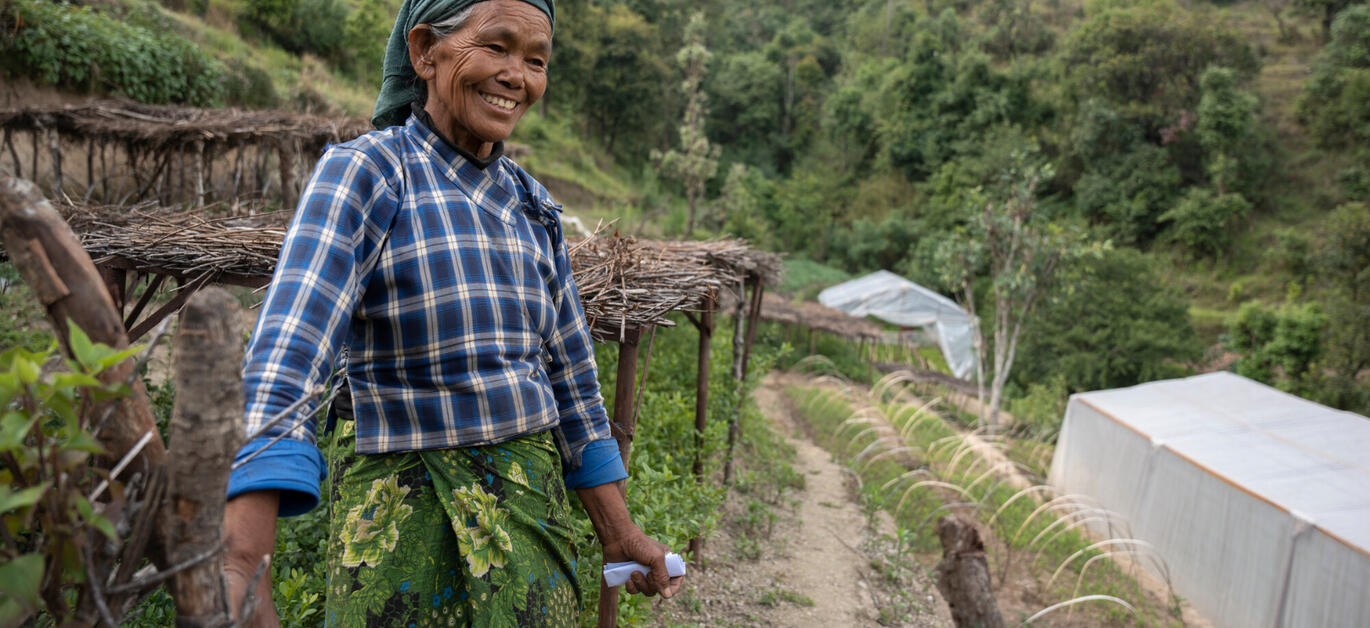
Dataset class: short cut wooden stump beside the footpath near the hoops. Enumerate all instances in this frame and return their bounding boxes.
[937,516,1004,628]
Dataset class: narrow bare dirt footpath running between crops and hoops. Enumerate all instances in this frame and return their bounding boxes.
[662,376,951,628]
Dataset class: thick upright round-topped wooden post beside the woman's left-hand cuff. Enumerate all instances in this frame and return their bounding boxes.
[160,288,242,628]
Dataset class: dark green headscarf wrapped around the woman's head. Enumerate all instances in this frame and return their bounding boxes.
[371,0,556,129]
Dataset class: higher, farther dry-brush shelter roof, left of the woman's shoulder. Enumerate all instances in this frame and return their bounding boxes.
[0,100,371,152]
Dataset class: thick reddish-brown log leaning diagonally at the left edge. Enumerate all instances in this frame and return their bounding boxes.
[0,178,166,496]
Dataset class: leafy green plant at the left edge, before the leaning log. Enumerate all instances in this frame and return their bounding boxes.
[0,320,140,625]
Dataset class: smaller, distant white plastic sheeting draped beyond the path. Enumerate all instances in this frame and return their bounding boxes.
[818,270,975,380]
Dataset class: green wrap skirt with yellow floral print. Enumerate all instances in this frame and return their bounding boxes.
[325,421,581,628]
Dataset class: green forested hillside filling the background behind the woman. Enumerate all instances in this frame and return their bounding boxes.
[0,0,1370,421]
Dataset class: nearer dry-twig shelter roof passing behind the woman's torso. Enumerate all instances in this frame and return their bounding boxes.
[18,206,780,340]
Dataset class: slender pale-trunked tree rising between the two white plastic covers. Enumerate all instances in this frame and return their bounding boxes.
[938,152,1107,429]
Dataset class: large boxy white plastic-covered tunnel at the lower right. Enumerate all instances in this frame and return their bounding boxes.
[1049,373,1370,628]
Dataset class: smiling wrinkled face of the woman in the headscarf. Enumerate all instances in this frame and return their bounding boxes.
[410,0,552,156]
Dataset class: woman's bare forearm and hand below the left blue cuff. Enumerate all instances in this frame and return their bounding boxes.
[223,491,281,628]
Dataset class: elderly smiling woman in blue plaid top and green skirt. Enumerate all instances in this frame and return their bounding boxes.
[225,0,681,627]
